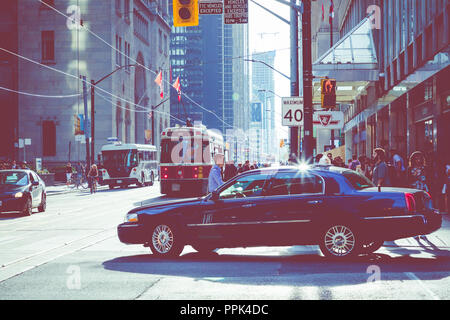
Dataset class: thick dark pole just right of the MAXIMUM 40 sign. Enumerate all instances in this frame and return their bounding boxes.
[302,0,314,162]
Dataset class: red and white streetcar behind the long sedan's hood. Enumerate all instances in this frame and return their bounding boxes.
[160,126,224,196]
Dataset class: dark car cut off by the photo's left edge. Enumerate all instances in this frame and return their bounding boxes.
[0,169,47,215]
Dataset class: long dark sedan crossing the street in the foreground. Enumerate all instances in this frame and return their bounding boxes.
[118,166,442,257]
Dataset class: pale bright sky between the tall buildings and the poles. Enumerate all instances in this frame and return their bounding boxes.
[248,0,290,138]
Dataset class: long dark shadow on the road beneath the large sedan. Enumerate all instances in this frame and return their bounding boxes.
[103,247,450,286]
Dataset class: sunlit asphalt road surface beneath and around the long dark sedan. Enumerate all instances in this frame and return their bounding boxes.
[0,184,450,300]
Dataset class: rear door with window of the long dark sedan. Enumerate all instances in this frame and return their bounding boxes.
[265,171,325,245]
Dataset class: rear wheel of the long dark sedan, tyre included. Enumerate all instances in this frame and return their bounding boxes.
[320,224,359,259]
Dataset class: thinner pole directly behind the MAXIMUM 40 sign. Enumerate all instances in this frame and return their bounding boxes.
[289,0,300,157]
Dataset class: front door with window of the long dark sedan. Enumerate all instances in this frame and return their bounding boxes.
[192,172,270,245]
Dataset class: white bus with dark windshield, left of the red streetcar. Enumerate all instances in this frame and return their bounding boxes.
[100,143,158,189]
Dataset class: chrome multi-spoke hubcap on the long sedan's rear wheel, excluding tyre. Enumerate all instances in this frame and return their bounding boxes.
[325,226,355,256]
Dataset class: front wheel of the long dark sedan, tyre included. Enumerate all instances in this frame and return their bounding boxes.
[150,224,184,258]
